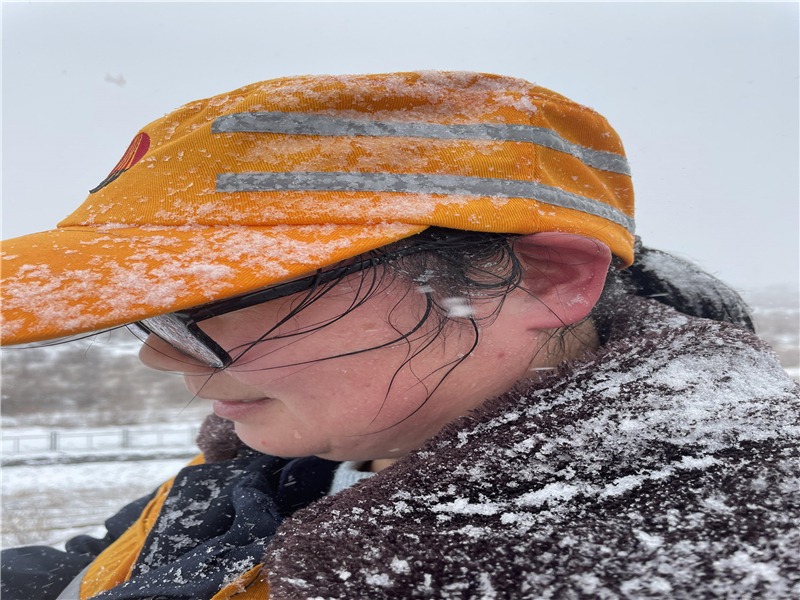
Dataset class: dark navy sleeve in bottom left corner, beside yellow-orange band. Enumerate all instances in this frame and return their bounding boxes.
[0,491,156,600]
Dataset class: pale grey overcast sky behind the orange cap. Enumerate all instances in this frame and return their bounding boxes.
[2,2,800,292]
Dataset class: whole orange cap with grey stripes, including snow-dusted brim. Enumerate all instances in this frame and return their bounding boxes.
[0,72,633,344]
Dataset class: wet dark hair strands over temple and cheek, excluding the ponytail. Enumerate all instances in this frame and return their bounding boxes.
[184,227,523,433]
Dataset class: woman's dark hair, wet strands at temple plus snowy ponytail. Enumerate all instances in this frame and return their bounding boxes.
[192,227,754,424]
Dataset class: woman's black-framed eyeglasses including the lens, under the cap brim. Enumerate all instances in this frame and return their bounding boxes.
[133,245,428,369]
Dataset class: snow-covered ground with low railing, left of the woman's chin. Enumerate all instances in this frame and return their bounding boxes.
[1,419,206,548]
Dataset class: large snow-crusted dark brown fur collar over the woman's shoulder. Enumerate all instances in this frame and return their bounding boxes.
[264,298,800,600]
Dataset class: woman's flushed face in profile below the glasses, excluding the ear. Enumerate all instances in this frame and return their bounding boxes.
[140,275,552,460]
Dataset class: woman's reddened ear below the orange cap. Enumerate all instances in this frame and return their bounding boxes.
[514,232,611,329]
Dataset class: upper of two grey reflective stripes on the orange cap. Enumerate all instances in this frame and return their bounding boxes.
[211,112,631,175]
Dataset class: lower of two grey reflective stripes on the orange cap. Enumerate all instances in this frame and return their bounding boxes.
[216,171,635,233]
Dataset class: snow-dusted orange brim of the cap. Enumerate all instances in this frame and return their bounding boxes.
[0,223,427,345]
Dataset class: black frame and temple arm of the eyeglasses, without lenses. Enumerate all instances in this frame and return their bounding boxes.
[132,244,430,369]
